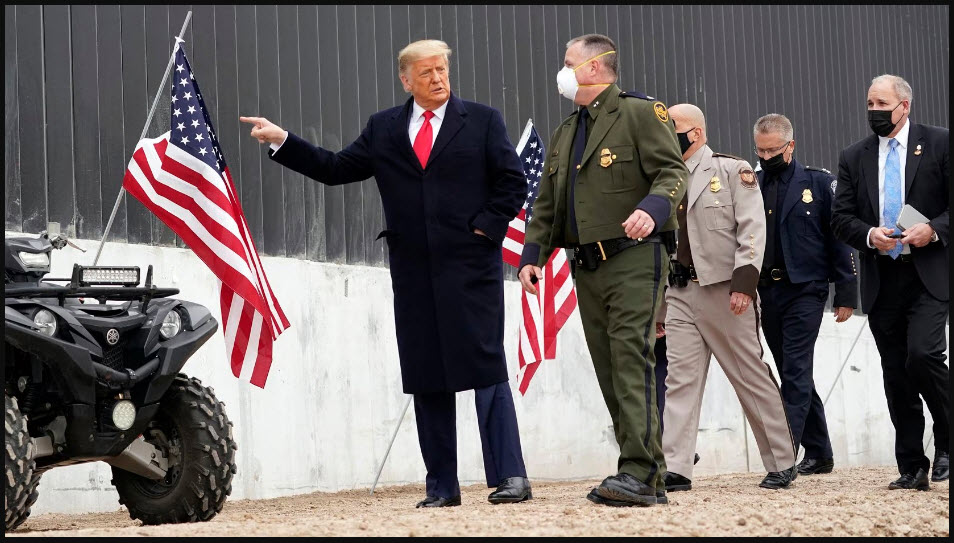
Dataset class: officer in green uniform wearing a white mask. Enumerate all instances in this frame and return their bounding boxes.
[520,34,688,506]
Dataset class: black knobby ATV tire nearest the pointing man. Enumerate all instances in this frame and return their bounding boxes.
[112,374,237,524]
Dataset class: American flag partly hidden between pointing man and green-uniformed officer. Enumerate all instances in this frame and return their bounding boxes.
[503,120,576,394]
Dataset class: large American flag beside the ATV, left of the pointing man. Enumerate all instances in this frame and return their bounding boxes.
[123,43,289,388]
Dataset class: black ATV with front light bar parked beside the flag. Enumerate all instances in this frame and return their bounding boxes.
[3,233,236,530]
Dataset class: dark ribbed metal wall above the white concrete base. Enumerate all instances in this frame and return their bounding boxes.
[4,5,950,265]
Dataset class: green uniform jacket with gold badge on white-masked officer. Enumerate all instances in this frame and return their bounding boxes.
[520,84,689,267]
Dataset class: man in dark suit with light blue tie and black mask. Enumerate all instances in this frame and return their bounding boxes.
[831,75,951,490]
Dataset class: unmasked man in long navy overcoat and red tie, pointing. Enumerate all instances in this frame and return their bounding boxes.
[242,40,531,507]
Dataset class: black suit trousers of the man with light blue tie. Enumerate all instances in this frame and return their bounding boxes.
[868,256,951,474]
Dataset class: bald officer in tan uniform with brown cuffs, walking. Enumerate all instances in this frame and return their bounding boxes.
[662,104,797,491]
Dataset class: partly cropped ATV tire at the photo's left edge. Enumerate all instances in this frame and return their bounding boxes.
[3,394,40,531]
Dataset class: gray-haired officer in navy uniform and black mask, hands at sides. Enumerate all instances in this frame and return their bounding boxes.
[753,113,858,475]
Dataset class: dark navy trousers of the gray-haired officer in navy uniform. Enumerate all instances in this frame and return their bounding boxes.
[759,279,834,458]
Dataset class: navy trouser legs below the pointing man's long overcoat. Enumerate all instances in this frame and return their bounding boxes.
[414,381,527,498]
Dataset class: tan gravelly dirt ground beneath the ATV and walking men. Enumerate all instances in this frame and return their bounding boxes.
[7,467,950,537]
